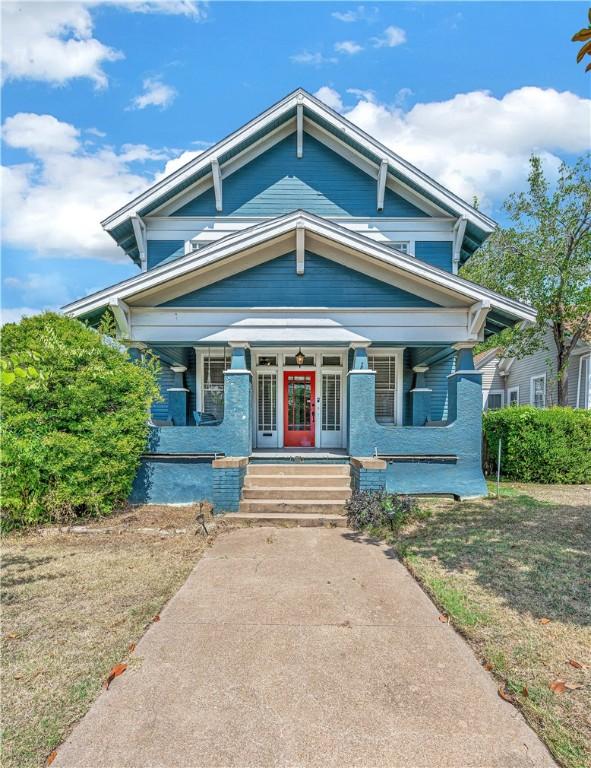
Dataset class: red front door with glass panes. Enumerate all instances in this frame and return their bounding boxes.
[283,371,316,448]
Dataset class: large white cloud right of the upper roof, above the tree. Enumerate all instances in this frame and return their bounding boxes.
[316,86,591,210]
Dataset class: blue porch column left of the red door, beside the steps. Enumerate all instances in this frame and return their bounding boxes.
[223,342,252,456]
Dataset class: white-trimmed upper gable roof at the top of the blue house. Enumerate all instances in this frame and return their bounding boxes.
[101,88,496,262]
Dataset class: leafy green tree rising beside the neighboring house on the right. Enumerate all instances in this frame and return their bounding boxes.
[461,154,591,405]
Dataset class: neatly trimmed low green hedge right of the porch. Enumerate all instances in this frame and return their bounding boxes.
[483,406,591,483]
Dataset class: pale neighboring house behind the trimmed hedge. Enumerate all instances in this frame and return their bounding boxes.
[474,329,591,410]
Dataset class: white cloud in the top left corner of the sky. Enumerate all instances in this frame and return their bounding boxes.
[2,2,123,88]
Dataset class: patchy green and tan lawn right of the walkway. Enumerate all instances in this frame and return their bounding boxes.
[395,484,591,768]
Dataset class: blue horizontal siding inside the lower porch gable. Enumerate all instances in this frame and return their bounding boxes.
[161,252,437,307]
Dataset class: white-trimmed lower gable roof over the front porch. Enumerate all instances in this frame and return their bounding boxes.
[63,211,536,330]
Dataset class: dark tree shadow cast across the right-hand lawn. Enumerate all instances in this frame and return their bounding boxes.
[344,493,591,626]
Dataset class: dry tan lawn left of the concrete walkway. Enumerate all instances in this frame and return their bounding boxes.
[1,507,215,768]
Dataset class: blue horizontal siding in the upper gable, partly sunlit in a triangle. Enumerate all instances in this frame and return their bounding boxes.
[172,133,427,217]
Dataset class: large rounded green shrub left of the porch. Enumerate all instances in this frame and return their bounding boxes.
[1,313,158,530]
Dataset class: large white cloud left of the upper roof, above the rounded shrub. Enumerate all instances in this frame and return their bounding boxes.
[2,113,185,262]
